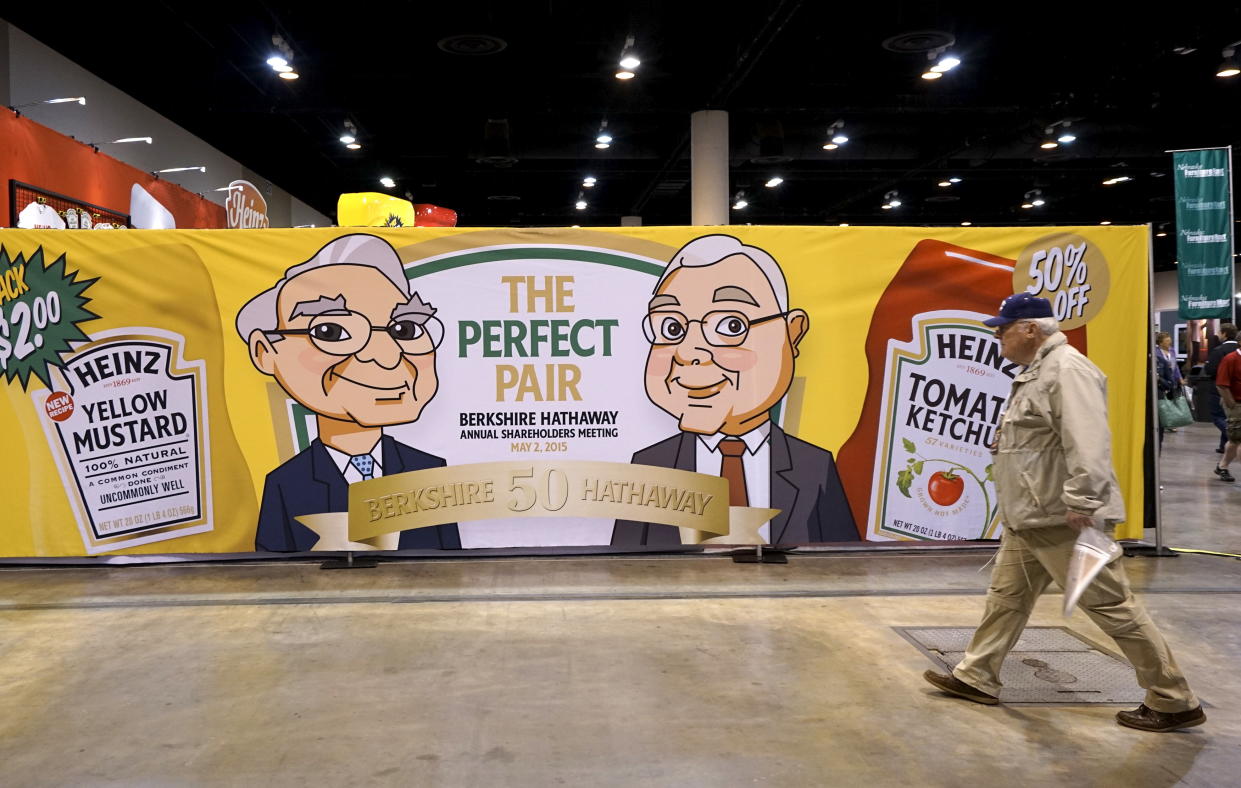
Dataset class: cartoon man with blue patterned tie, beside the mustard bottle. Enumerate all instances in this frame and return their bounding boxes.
[237,233,460,551]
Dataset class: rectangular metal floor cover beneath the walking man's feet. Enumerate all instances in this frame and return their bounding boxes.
[896,627,1145,704]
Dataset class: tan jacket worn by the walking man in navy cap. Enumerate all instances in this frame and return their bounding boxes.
[993,331,1124,530]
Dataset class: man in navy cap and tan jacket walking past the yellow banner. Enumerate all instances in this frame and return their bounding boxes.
[925,293,1201,731]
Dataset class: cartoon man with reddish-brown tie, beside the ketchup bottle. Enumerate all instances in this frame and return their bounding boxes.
[612,235,858,546]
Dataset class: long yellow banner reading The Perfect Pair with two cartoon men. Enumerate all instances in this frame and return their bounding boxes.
[0,227,1148,556]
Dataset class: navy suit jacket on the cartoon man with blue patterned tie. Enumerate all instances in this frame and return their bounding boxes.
[254,436,462,552]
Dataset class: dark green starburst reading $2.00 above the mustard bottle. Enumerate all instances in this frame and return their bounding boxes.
[0,247,99,390]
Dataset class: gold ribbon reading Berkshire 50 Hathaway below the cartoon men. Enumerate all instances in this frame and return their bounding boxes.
[298,460,779,550]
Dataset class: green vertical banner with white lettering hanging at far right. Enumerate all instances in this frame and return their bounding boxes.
[1173,148,1234,320]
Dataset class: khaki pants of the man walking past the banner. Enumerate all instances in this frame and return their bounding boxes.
[952,525,1198,714]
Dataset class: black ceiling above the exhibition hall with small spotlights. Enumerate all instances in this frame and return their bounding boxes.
[4,0,1241,267]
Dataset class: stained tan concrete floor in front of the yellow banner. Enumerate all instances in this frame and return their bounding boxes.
[0,426,1241,787]
